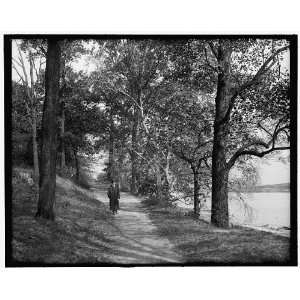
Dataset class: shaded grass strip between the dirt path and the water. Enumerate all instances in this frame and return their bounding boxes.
[145,203,290,265]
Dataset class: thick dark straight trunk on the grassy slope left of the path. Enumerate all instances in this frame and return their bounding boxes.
[36,39,61,220]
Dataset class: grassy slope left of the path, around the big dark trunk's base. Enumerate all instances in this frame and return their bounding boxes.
[12,168,120,263]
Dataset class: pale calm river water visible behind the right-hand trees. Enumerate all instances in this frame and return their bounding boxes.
[178,192,290,236]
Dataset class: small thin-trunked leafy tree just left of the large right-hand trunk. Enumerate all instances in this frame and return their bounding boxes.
[170,93,214,216]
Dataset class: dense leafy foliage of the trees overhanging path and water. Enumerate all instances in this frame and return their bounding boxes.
[12,38,291,221]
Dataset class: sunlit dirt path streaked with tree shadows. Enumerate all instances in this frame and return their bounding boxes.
[90,188,181,264]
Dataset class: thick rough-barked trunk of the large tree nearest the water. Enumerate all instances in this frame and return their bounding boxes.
[211,46,232,228]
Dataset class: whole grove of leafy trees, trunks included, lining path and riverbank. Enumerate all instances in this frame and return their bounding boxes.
[12,36,290,228]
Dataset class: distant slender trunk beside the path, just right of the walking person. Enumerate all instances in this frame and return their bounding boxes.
[130,111,140,194]
